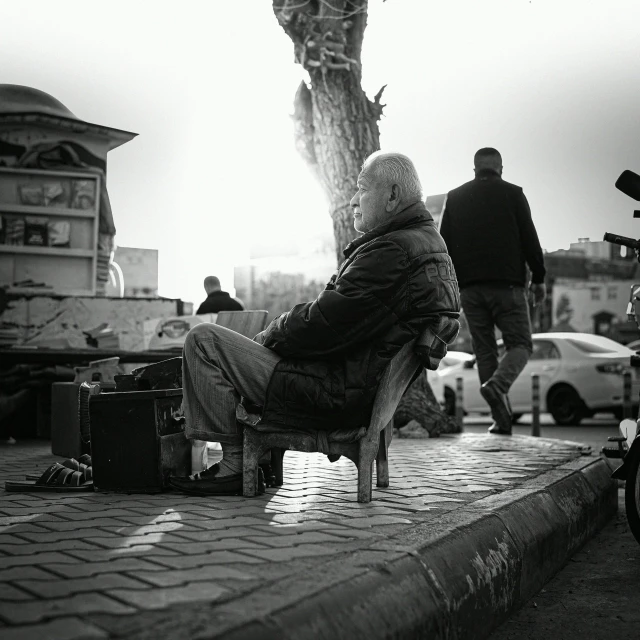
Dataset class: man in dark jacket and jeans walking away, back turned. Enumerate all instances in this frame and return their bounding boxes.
[440,148,546,435]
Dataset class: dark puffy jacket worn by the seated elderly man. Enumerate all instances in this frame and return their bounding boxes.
[255,202,460,430]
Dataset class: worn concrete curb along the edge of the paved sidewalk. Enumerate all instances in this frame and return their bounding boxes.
[198,458,618,640]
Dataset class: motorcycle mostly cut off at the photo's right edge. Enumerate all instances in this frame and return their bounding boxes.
[602,170,640,543]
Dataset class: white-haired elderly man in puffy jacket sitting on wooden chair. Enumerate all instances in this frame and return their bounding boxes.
[171,152,460,495]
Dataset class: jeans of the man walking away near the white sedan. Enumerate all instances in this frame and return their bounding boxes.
[460,285,533,393]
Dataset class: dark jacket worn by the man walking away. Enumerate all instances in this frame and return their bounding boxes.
[440,172,545,289]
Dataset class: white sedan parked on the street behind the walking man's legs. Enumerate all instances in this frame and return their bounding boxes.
[438,333,640,425]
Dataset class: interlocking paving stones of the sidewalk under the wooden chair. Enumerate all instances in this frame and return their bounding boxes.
[0,434,580,640]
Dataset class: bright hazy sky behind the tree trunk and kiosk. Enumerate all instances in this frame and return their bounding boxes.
[0,0,640,301]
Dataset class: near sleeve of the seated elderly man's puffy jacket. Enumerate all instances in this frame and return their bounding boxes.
[256,240,409,359]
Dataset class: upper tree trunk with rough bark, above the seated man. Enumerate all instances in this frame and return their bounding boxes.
[273,0,384,264]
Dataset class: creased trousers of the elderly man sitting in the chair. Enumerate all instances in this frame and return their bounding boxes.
[182,323,281,448]
